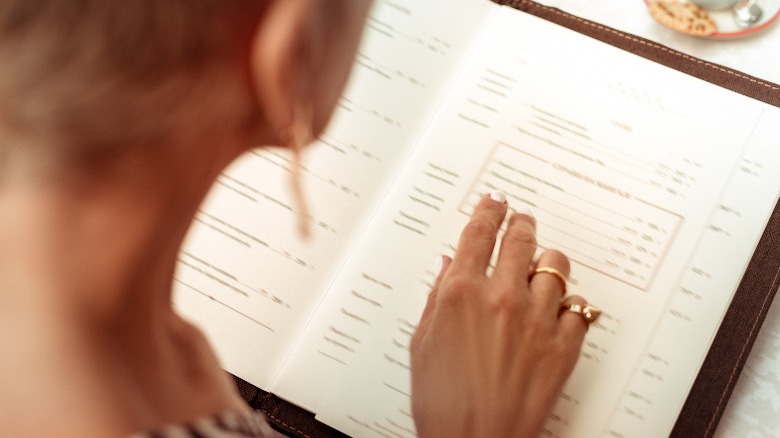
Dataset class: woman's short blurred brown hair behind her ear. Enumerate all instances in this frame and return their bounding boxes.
[0,0,266,167]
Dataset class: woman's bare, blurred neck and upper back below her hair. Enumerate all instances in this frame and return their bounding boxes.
[0,146,247,436]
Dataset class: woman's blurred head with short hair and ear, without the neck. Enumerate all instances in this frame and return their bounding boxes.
[0,0,369,176]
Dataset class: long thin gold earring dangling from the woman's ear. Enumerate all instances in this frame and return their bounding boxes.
[285,102,314,238]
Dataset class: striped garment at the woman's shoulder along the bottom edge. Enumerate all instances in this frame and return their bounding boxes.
[128,411,284,438]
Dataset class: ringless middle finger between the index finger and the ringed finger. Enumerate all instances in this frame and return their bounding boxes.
[493,212,536,284]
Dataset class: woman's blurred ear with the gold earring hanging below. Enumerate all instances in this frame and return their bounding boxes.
[249,0,316,144]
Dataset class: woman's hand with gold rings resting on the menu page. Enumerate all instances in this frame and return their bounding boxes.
[411,194,587,438]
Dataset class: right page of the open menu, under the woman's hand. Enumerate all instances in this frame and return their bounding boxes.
[300,9,780,436]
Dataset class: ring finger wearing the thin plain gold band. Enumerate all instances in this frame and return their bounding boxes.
[529,249,571,314]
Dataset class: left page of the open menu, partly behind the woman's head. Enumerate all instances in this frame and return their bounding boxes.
[175,0,496,388]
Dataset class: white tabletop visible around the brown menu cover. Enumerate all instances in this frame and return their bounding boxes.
[536,0,780,438]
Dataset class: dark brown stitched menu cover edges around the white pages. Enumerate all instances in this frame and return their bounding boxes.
[236,0,780,437]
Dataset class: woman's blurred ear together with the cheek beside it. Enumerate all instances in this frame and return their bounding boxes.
[250,0,371,144]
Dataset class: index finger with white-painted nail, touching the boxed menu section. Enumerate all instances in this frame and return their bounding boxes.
[452,192,507,275]
